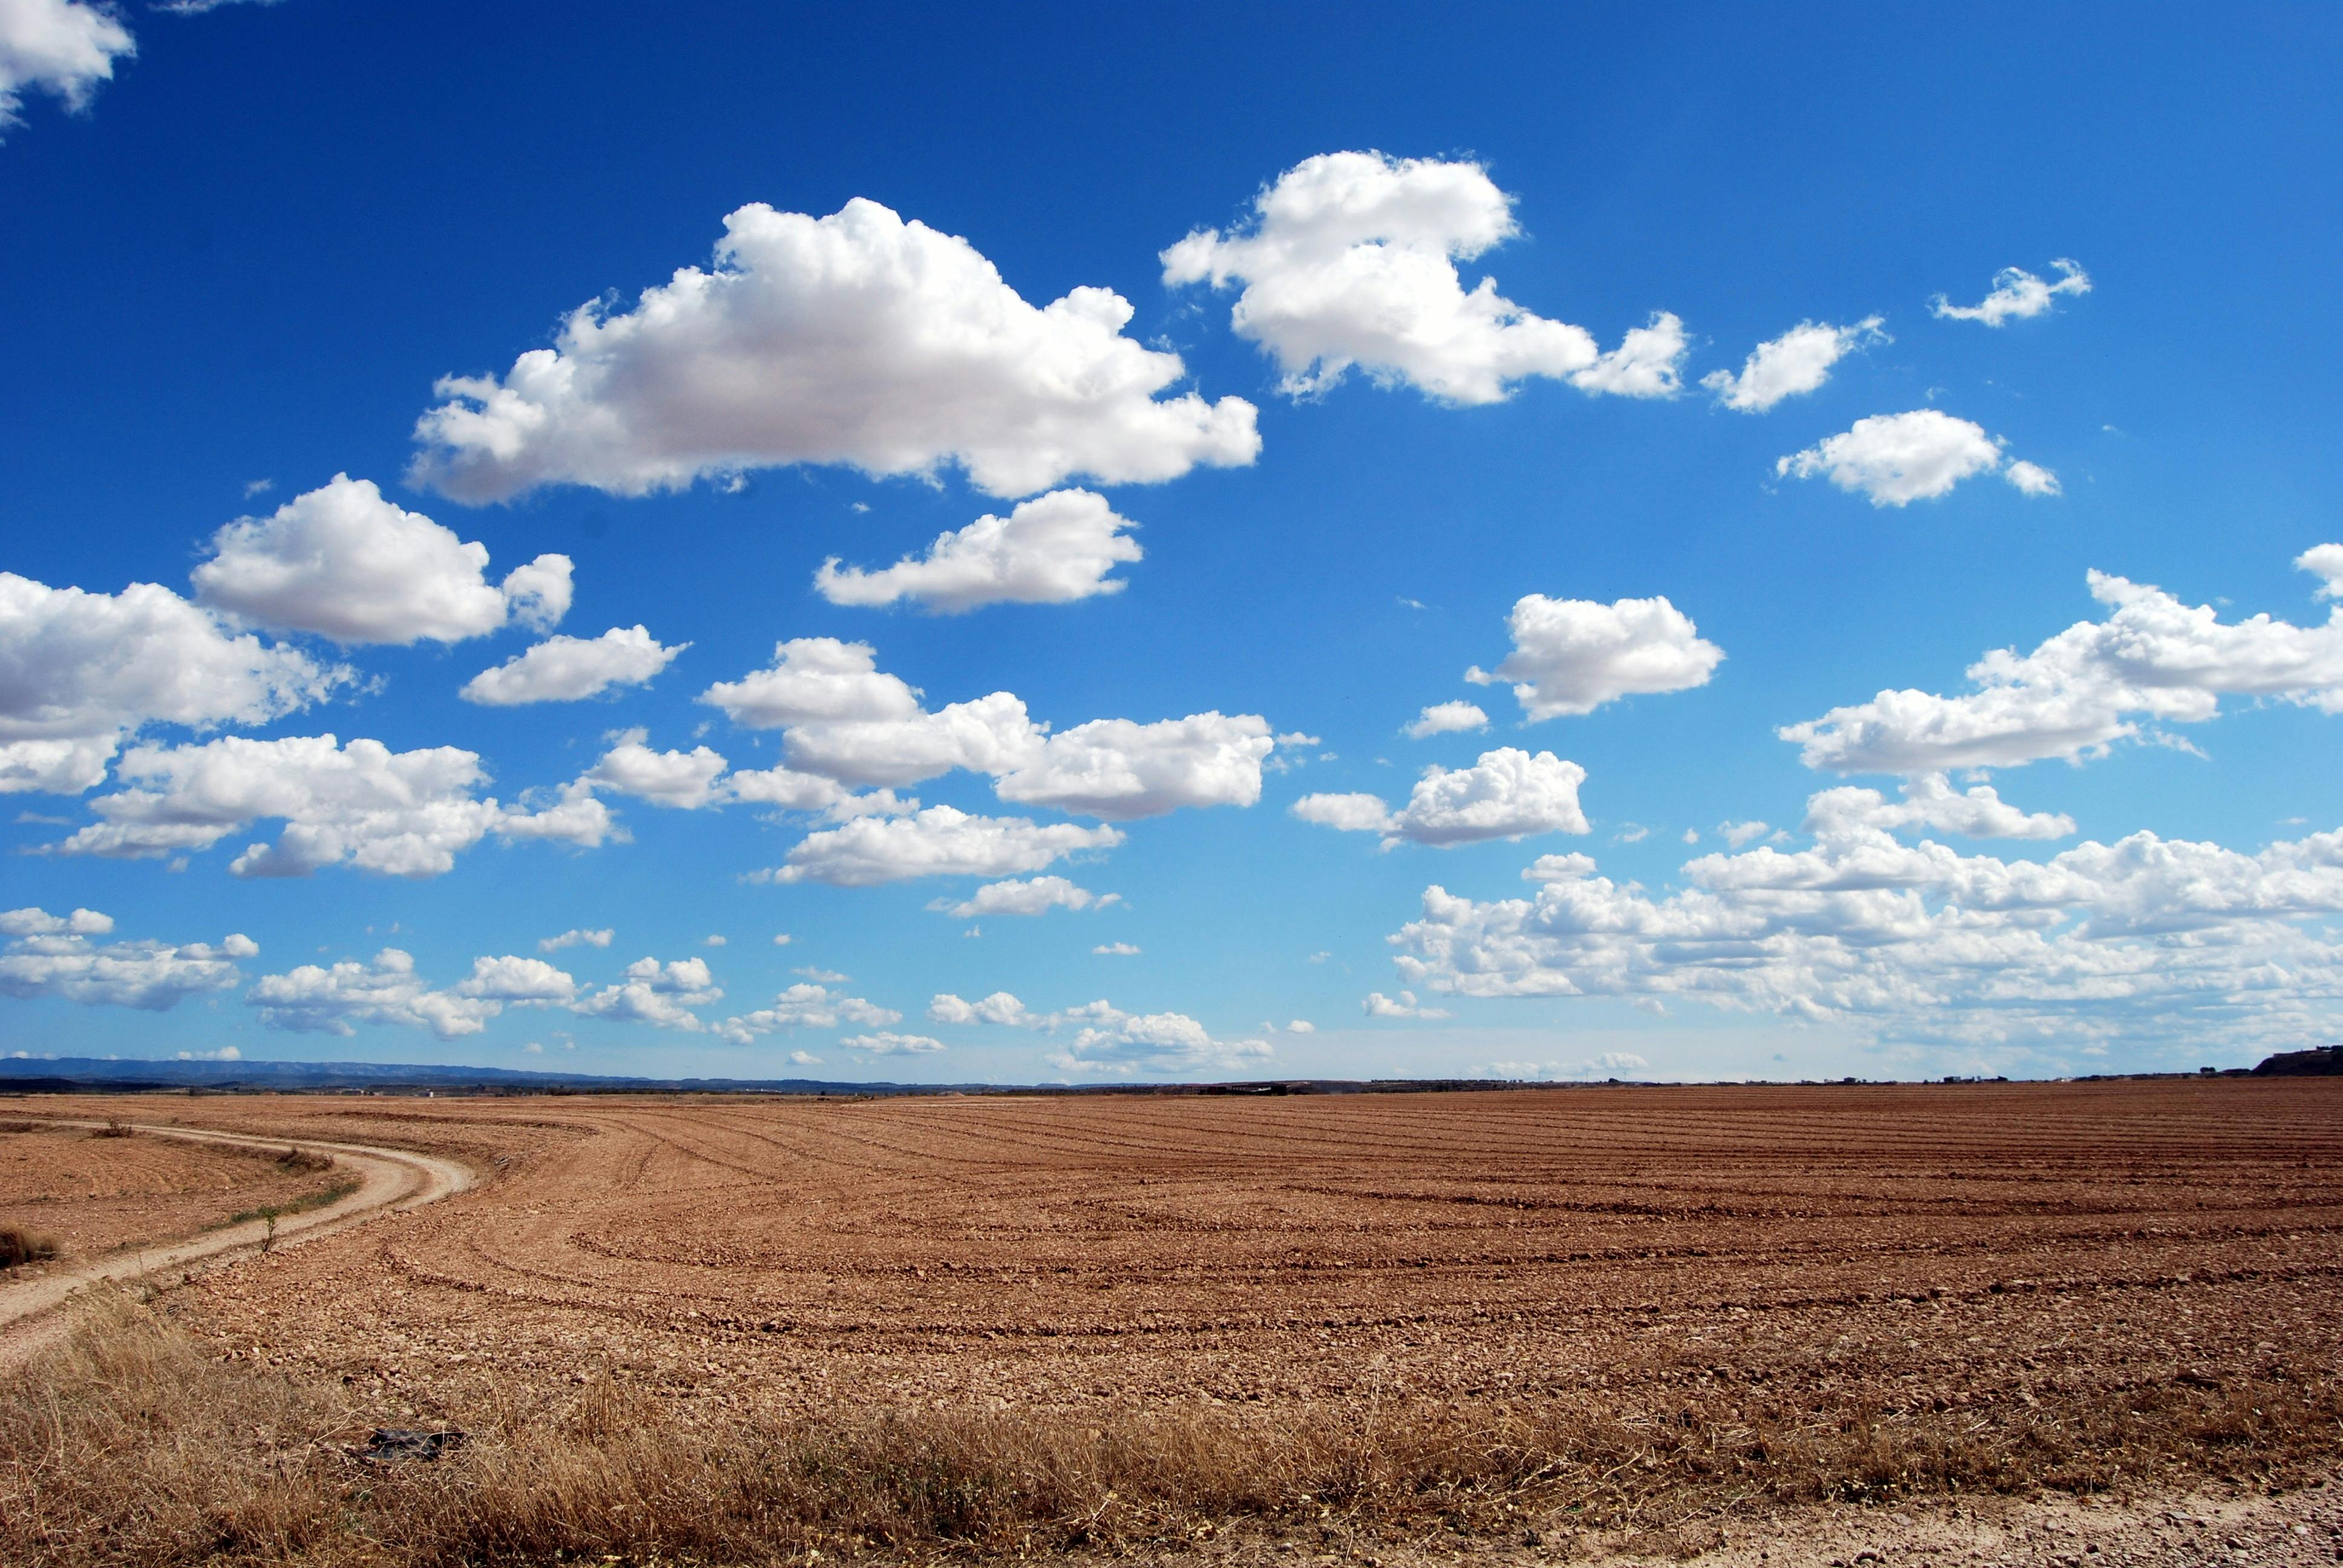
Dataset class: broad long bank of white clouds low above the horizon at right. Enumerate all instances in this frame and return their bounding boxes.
[1392,783,2343,1050]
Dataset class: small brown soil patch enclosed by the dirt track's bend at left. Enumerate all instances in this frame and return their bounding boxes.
[0,1116,351,1261]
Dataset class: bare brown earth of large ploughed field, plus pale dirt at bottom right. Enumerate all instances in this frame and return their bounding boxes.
[0,1080,2343,1568]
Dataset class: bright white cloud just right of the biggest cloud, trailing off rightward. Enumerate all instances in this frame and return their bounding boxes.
[1162,152,1685,403]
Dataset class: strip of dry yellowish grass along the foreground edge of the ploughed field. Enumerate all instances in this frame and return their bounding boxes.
[0,1296,2343,1568]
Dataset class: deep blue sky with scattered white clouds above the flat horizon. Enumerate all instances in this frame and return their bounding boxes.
[0,0,2343,1080]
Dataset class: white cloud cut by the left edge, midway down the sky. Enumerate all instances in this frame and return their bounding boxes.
[0,572,352,794]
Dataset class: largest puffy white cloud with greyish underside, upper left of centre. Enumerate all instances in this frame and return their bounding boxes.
[415,199,1260,501]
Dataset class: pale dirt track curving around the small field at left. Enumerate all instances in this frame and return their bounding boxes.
[0,1118,473,1367]
